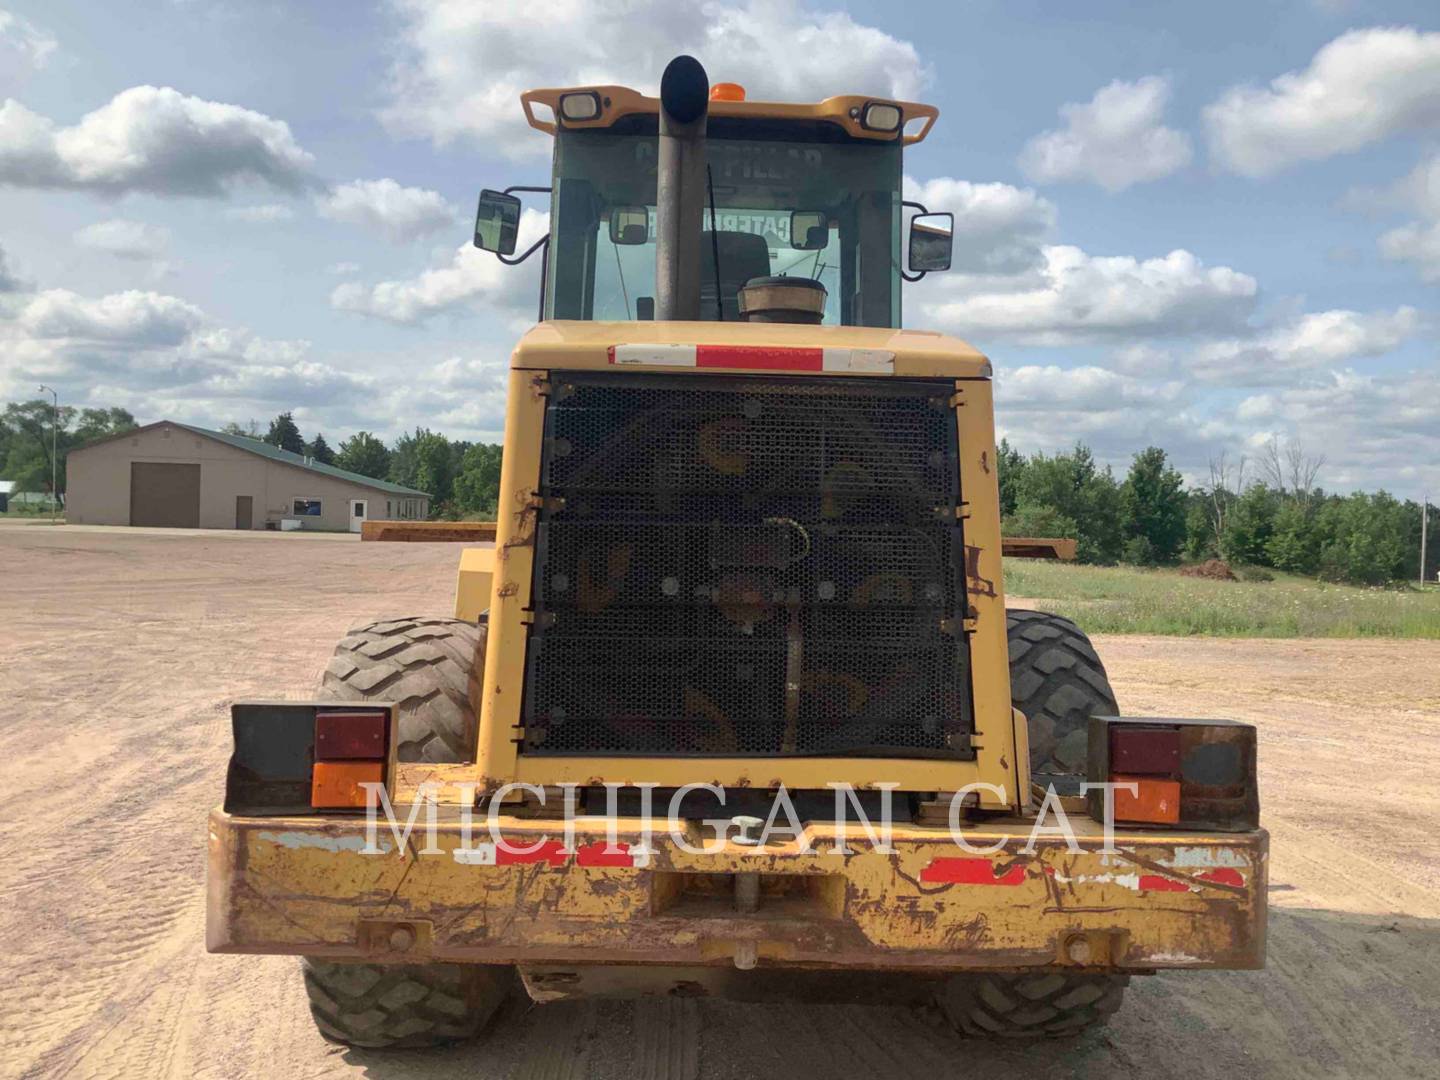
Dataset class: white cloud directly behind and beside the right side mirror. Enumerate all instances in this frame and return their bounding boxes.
[904,176,1056,274]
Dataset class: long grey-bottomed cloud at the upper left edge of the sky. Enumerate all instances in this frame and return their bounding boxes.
[0,86,312,196]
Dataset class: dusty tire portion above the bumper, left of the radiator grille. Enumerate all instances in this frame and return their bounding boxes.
[320,618,485,763]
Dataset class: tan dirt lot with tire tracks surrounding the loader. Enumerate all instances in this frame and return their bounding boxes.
[0,524,1440,1080]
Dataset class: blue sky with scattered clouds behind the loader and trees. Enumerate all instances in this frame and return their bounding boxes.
[0,0,1440,497]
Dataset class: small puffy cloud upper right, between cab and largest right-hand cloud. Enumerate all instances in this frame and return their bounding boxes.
[1020,75,1192,192]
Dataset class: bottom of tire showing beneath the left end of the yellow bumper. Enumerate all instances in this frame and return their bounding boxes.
[301,958,516,1048]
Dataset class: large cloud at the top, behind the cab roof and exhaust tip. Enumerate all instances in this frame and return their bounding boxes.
[380,0,929,157]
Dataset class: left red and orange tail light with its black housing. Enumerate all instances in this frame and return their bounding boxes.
[225,701,393,816]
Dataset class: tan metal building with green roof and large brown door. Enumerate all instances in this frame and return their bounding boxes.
[65,420,431,533]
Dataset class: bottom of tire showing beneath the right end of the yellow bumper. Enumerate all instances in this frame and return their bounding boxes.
[936,971,1130,1038]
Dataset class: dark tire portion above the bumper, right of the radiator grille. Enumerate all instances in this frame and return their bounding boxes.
[1005,611,1119,788]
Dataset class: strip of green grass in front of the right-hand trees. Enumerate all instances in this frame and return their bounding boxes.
[1005,559,1440,638]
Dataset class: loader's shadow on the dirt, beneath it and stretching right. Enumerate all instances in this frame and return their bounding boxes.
[334,907,1440,1080]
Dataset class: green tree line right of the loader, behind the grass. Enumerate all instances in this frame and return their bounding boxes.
[996,441,1440,585]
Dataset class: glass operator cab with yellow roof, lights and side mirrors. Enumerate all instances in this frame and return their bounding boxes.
[475,84,953,327]
